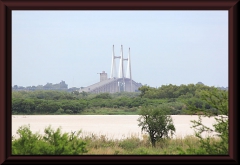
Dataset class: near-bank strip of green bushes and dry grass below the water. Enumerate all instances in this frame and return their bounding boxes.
[12,126,224,155]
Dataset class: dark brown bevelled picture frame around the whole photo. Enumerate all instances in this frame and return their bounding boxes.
[0,0,239,164]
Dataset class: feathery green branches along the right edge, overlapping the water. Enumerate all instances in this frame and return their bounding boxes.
[181,89,229,154]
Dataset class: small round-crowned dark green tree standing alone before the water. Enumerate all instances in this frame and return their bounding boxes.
[137,106,176,147]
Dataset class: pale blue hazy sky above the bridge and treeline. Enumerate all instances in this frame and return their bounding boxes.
[12,10,228,88]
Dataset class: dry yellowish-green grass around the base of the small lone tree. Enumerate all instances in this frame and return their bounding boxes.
[79,135,217,155]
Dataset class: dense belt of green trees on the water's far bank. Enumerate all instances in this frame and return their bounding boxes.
[12,83,227,115]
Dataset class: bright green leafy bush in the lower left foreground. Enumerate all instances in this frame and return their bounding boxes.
[12,125,87,155]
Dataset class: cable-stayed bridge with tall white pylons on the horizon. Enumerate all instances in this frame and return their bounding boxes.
[79,46,142,93]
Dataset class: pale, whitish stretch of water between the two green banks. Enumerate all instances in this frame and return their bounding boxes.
[12,115,219,139]
